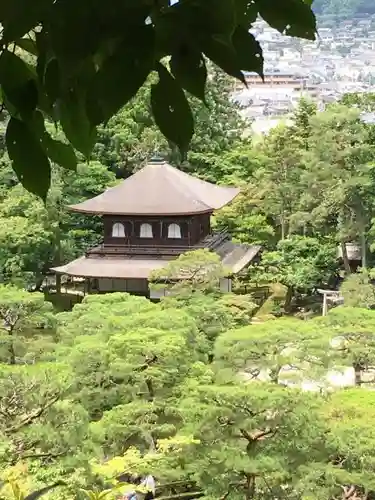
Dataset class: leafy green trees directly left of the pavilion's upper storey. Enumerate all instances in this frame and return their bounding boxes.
[0,162,115,289]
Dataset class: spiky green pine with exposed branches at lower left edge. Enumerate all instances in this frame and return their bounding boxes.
[0,363,90,470]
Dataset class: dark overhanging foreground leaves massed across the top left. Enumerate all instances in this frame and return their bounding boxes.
[0,0,316,199]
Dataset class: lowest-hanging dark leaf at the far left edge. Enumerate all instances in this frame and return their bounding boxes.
[5,118,51,201]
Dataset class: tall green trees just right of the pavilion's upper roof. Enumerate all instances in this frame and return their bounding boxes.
[215,99,316,248]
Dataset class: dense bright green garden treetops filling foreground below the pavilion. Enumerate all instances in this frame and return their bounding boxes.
[0,278,375,500]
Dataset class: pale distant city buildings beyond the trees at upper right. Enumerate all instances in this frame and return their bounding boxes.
[233,16,375,133]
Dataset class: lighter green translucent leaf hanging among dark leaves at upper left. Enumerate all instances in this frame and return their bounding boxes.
[57,90,96,158]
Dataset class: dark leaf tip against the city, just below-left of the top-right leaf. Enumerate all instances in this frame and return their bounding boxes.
[232,26,264,76]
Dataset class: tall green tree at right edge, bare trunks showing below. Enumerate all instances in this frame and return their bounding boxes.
[301,105,374,269]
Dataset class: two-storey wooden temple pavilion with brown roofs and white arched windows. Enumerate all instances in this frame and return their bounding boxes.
[52,158,260,298]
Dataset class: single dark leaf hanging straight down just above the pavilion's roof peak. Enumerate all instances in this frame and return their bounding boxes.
[151,64,194,152]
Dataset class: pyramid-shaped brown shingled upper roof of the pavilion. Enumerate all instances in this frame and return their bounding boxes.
[69,160,240,215]
